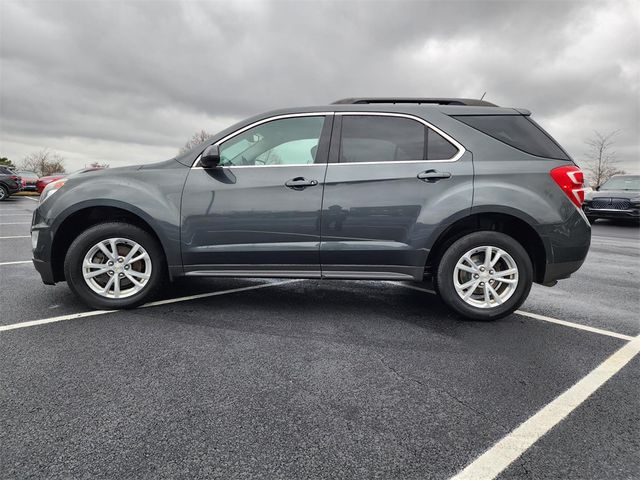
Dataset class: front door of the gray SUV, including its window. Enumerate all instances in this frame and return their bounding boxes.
[181,114,333,278]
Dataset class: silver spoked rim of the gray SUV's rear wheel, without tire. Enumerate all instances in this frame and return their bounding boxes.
[453,245,518,308]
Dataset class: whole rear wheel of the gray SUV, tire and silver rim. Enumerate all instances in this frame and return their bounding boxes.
[436,231,533,320]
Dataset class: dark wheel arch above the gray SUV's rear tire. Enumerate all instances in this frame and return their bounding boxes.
[425,207,549,283]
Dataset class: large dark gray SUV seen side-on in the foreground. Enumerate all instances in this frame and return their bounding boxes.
[32,98,591,320]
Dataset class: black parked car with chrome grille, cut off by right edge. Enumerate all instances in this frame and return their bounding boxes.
[582,175,640,223]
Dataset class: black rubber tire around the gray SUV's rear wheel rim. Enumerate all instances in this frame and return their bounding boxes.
[435,231,533,321]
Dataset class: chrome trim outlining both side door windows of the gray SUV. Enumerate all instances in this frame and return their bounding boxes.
[191,111,467,170]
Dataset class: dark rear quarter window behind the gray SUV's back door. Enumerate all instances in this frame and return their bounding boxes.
[454,115,569,160]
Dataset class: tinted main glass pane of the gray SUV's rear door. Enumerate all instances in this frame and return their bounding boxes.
[340,115,426,163]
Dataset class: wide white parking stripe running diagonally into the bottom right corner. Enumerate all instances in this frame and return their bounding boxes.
[451,336,640,480]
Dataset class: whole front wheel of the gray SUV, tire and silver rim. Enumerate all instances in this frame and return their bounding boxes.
[64,222,166,309]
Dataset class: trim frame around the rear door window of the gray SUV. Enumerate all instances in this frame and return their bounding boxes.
[329,111,467,165]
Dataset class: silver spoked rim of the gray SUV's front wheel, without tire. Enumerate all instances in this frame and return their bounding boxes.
[82,238,151,299]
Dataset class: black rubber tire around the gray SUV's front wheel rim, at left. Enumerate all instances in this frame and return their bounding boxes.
[64,222,167,310]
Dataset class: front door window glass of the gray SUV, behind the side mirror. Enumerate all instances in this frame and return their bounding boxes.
[220,116,325,166]
